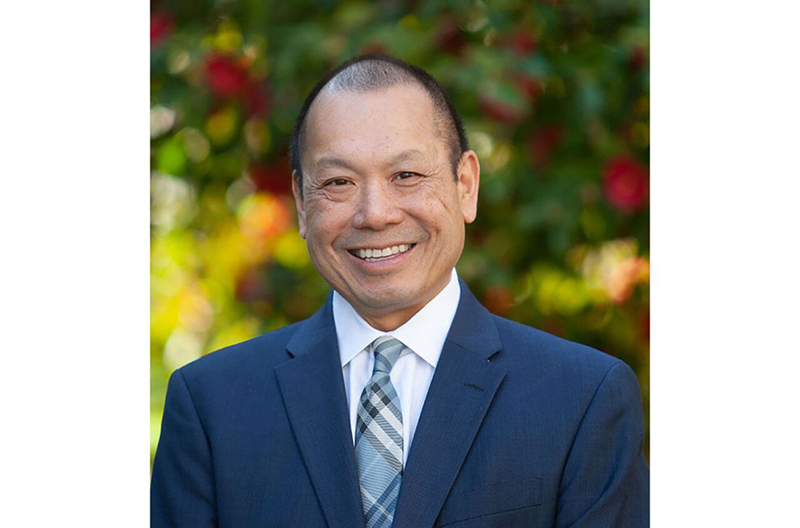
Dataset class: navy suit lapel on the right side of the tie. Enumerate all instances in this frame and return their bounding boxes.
[392,282,506,528]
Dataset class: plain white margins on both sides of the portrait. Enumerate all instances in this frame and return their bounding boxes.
[0,0,800,527]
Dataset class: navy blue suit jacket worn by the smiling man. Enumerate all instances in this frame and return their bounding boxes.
[151,282,649,528]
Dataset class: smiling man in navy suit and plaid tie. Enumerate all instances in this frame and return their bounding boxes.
[152,56,649,528]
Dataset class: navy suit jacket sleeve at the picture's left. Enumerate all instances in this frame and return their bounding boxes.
[150,370,218,528]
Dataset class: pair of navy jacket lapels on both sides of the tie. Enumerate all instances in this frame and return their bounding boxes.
[275,281,506,528]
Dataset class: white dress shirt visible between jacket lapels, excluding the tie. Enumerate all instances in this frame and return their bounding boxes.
[333,268,461,466]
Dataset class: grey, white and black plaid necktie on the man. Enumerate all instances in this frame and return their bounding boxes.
[356,336,404,528]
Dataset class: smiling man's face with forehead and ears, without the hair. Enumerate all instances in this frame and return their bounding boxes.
[295,86,480,330]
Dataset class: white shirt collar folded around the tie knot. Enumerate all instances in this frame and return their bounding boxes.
[333,268,461,368]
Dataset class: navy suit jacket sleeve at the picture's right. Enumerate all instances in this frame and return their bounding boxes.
[556,362,650,528]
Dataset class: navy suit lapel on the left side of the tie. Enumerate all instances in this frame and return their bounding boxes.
[275,297,364,528]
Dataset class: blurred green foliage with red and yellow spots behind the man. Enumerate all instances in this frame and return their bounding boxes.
[150,0,649,462]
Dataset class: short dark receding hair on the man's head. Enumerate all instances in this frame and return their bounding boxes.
[289,53,469,193]
